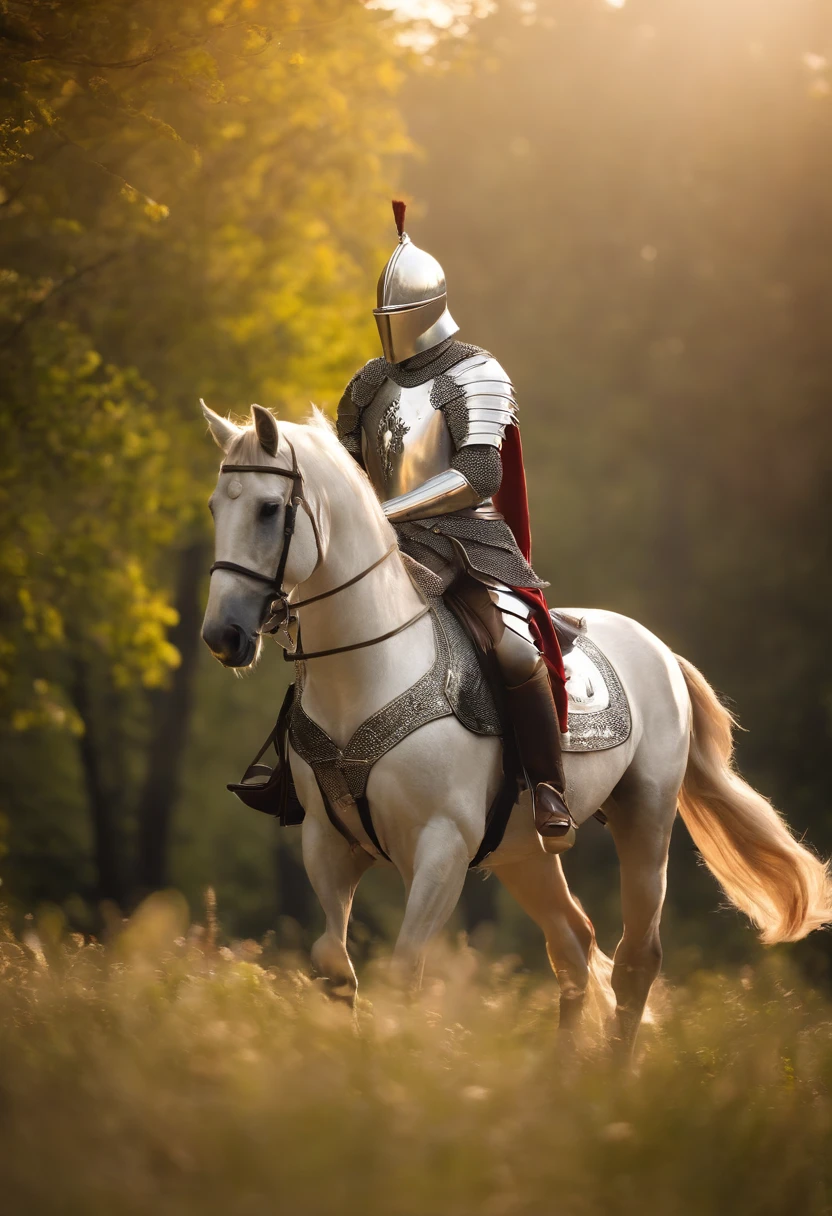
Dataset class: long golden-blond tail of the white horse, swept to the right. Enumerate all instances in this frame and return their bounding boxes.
[676,657,832,945]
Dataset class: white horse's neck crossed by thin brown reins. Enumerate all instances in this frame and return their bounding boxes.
[287,447,433,743]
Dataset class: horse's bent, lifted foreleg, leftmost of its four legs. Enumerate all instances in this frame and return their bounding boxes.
[303,815,372,1006]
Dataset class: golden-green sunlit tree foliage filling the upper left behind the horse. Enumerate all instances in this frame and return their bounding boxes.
[0,0,413,728]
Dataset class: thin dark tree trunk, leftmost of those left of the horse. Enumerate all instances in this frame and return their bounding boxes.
[71,659,127,908]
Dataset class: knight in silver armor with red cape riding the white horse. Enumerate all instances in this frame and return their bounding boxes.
[338,202,575,852]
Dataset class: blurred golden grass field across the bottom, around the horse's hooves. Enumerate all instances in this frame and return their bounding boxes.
[0,899,832,1216]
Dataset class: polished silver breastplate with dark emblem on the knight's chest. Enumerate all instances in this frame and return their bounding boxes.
[361,379,455,502]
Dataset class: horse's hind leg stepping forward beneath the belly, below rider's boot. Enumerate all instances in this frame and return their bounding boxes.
[494,854,595,1030]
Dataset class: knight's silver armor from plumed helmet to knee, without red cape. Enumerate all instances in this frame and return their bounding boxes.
[338,204,541,685]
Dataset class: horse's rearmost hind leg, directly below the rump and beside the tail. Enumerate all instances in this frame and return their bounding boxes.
[608,783,678,1058]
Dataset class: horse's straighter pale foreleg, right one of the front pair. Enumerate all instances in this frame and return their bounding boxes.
[393,818,470,985]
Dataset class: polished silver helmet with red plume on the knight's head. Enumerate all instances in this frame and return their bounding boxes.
[373,201,459,364]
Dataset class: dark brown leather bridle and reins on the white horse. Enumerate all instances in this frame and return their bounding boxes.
[209,440,431,663]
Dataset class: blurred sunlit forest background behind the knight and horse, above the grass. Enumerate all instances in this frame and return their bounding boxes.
[0,0,832,980]
